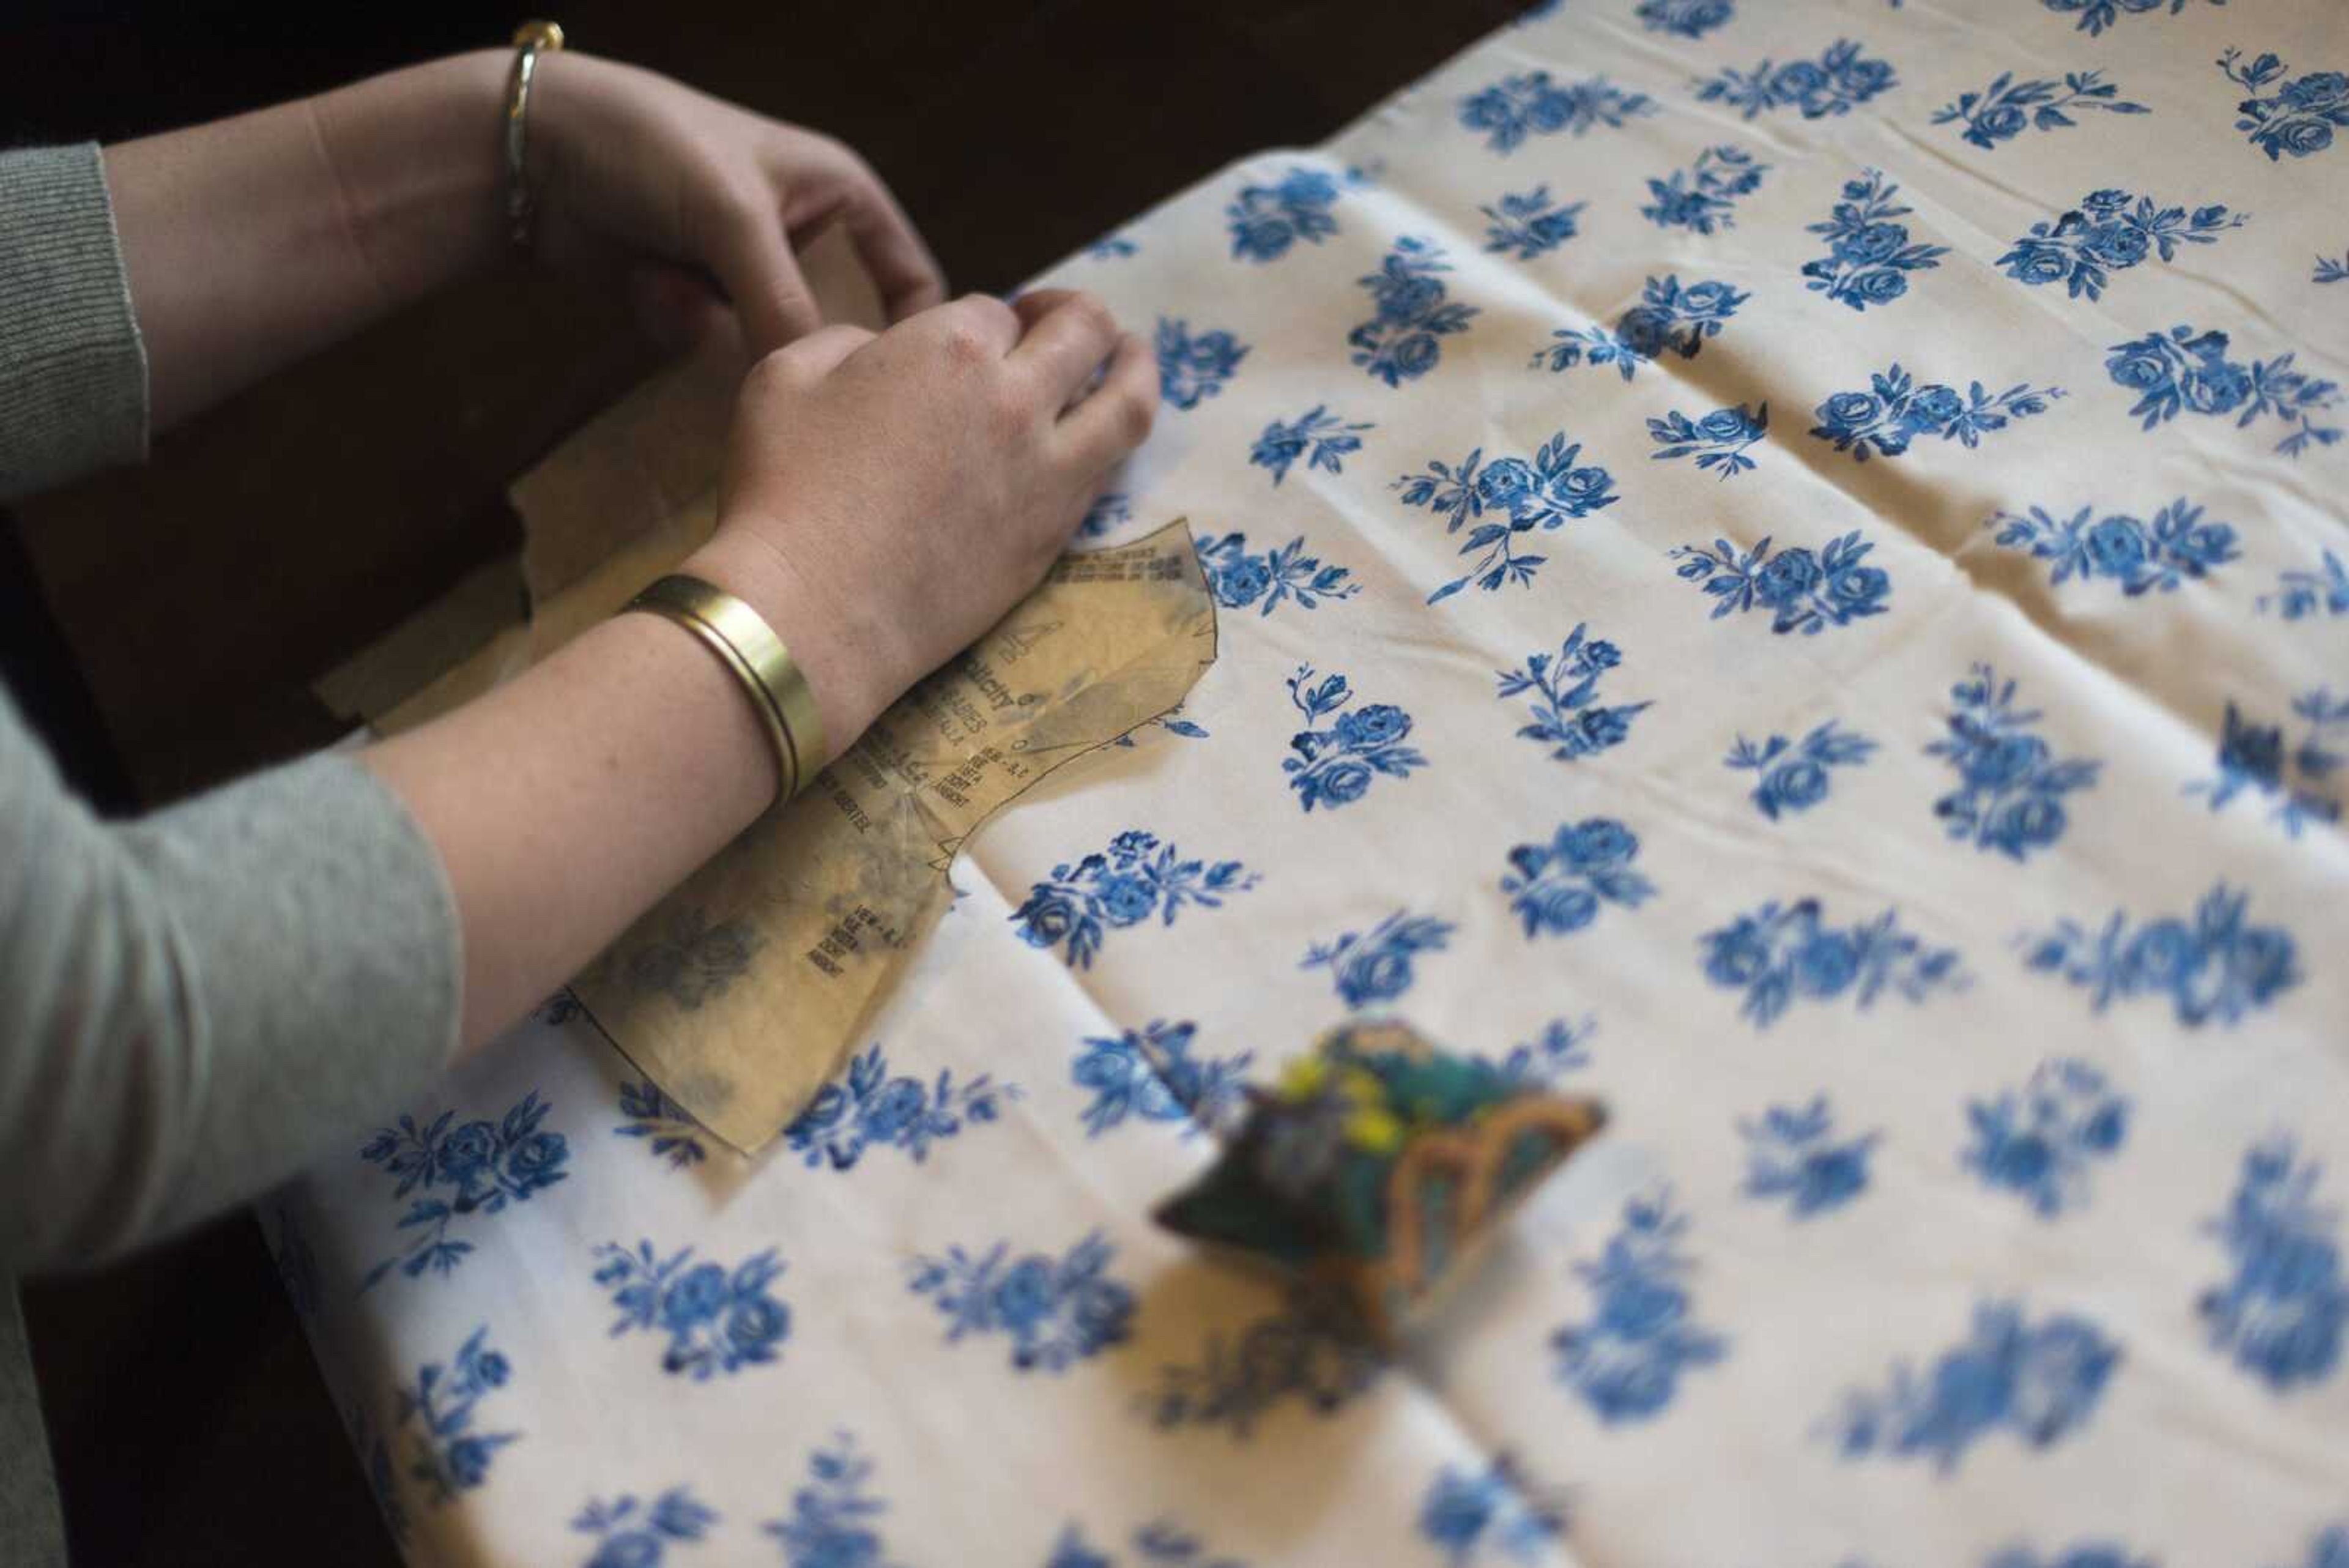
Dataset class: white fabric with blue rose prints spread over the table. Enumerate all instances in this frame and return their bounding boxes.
[284,0,2349,1568]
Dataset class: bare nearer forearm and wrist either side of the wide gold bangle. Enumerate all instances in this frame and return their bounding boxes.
[364,541,888,1051]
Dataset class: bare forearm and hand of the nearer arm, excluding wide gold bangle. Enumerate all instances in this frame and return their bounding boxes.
[366,291,1158,1049]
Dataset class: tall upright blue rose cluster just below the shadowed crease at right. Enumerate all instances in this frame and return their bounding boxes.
[1924,665,2105,860]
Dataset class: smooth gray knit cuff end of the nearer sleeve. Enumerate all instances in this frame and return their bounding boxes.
[125,754,462,1230]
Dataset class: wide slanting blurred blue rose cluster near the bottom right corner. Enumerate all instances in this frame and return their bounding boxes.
[1828,1300,2121,1471]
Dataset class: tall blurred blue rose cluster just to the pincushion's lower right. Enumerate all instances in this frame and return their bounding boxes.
[1550,1189,1729,1427]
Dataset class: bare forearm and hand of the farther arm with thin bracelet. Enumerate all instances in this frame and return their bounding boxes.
[106,50,944,430]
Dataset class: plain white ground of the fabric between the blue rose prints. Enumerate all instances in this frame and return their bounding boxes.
[284,0,2349,1568]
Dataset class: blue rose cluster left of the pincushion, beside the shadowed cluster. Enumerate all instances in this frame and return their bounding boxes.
[907,1232,1135,1373]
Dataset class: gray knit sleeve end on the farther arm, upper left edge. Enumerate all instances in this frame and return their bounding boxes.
[0,141,148,500]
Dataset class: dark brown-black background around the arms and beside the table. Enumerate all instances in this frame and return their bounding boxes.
[0,0,1522,1568]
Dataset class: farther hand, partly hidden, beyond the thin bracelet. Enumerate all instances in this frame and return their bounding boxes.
[529,52,947,355]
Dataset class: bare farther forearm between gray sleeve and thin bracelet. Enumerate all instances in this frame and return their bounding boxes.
[106,50,510,430]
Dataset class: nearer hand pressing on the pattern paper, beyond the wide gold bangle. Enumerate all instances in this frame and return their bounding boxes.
[686,289,1158,754]
